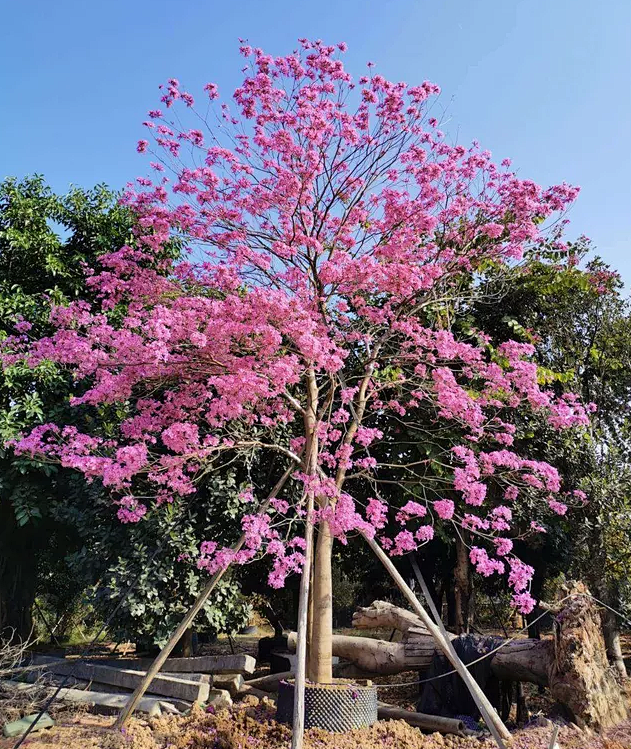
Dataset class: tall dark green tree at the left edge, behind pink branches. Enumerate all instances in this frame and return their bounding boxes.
[0,176,137,637]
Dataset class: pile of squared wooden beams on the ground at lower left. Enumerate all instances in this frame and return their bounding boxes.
[0,655,256,715]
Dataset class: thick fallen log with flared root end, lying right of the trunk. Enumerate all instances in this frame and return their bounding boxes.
[288,583,627,729]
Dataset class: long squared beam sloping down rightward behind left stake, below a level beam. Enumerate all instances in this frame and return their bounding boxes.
[33,655,210,703]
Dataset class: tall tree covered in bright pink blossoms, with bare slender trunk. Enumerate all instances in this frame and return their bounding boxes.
[5,40,588,682]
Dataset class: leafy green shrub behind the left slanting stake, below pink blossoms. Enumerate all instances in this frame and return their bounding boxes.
[54,470,250,646]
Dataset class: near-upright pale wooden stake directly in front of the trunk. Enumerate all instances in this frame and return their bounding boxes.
[291,493,313,749]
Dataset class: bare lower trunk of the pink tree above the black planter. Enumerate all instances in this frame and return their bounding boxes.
[309,521,333,684]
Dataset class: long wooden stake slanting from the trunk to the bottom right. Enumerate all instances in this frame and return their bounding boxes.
[364,536,511,749]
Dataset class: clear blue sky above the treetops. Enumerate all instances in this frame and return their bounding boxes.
[0,0,631,285]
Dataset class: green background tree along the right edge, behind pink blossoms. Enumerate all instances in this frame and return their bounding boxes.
[475,239,631,673]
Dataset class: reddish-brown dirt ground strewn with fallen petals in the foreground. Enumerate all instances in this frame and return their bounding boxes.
[0,631,631,749]
